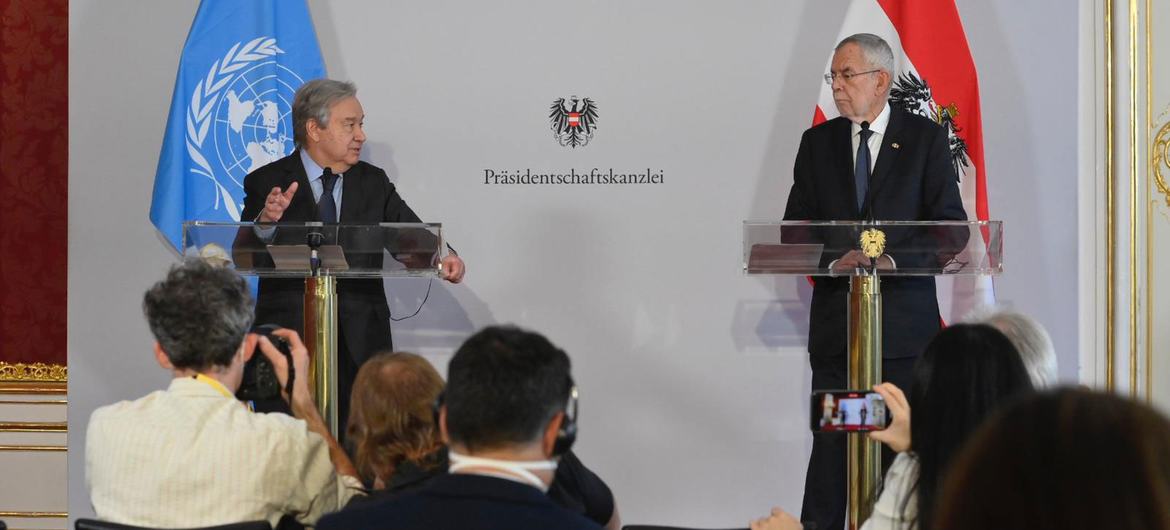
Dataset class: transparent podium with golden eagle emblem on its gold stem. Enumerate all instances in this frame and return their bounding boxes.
[743,221,1003,529]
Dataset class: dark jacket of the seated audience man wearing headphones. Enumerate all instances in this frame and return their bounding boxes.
[317,474,601,530]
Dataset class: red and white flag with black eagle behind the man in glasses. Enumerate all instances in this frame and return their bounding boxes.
[813,0,995,322]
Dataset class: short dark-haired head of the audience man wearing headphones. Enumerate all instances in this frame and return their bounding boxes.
[445,326,573,456]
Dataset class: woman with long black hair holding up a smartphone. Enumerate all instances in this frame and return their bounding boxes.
[752,324,1033,530]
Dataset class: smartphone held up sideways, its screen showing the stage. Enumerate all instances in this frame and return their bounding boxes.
[808,390,889,433]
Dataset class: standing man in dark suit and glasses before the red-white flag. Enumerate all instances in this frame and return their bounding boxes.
[784,34,966,530]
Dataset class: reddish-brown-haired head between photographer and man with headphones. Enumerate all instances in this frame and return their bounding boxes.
[346,352,442,482]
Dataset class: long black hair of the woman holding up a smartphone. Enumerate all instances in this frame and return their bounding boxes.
[909,324,1032,529]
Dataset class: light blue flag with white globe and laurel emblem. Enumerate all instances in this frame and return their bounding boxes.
[150,0,325,254]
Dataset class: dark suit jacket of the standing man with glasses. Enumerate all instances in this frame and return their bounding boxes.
[784,108,966,360]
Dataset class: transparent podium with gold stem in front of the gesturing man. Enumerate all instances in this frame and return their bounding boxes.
[183,221,443,436]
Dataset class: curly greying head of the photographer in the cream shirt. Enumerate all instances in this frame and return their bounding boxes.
[143,259,253,372]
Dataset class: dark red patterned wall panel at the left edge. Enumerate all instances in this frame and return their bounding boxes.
[0,0,69,365]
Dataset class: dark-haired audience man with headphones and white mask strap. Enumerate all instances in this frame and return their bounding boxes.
[319,326,601,530]
